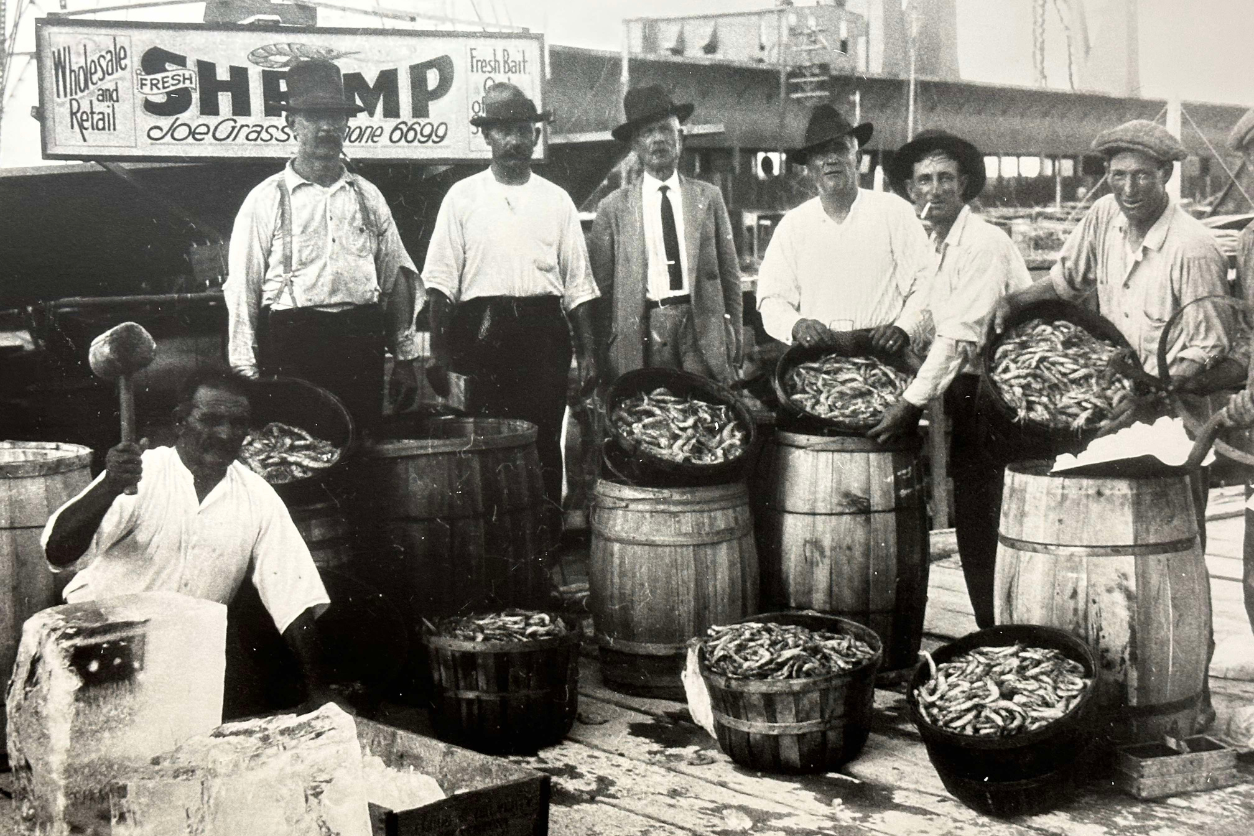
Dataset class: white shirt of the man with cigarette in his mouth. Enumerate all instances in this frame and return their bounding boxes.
[902,207,1032,406]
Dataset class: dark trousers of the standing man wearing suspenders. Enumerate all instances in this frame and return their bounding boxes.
[257,305,385,432]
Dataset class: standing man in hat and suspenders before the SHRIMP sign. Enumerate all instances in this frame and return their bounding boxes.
[223,60,419,429]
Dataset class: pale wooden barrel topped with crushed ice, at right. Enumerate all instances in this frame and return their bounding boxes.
[994,462,1210,743]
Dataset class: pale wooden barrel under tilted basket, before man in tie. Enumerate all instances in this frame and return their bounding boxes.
[588,479,757,699]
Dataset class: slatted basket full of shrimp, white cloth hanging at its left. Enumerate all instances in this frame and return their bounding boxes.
[697,612,883,773]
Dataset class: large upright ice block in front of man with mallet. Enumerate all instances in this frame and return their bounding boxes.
[6,592,227,836]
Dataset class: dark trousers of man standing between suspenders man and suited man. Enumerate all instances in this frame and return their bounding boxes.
[449,296,572,535]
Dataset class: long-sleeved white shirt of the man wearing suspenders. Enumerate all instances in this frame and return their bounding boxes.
[222,162,421,370]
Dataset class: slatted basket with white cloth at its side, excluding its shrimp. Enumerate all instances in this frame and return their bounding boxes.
[701,613,883,773]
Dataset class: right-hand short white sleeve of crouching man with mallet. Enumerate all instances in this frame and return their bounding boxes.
[252,496,331,633]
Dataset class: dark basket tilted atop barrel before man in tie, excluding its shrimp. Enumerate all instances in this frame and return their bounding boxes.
[602,368,756,488]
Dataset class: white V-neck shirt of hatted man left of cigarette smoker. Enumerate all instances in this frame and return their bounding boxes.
[757,189,935,342]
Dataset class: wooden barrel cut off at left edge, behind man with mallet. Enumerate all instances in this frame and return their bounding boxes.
[0,441,92,747]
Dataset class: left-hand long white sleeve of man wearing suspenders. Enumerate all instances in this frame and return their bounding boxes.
[222,188,277,371]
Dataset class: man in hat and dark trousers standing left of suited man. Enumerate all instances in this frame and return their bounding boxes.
[423,83,598,543]
